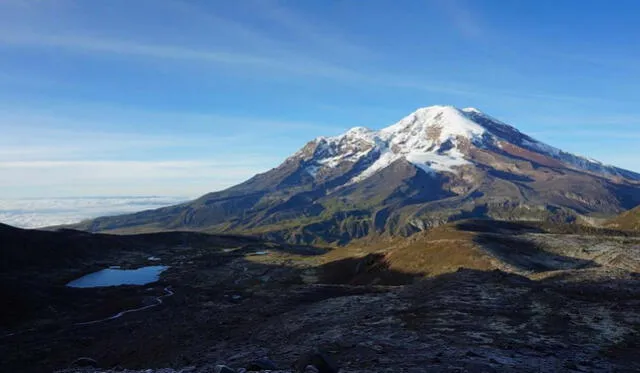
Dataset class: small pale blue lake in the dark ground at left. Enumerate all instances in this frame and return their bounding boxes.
[67,266,169,288]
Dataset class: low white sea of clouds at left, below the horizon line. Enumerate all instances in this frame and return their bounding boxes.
[0,196,189,228]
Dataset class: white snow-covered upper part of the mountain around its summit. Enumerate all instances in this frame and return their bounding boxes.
[292,106,640,183]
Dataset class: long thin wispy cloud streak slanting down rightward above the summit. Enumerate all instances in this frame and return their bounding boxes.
[0,24,608,103]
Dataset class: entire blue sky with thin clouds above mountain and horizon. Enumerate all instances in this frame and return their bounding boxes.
[0,0,640,198]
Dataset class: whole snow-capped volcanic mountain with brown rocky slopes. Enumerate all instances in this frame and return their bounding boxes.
[70,106,640,244]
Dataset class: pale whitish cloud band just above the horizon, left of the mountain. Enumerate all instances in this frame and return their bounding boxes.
[0,154,274,197]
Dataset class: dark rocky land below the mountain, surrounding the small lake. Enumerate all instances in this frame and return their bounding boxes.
[0,220,640,372]
